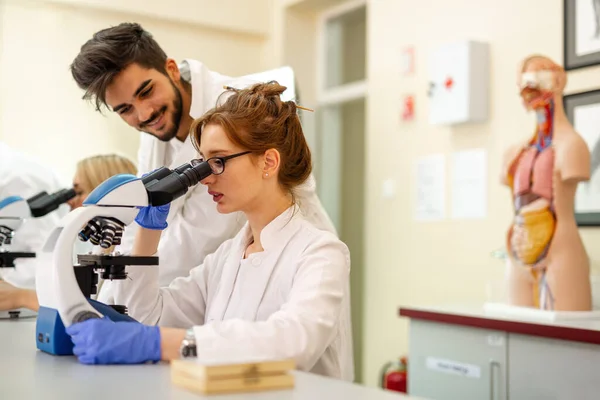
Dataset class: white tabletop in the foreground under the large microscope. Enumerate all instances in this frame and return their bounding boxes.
[0,318,414,400]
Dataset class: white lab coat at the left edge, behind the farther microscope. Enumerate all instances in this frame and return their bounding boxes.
[0,142,69,289]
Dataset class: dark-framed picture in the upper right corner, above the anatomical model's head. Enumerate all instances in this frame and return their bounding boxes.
[563,0,600,70]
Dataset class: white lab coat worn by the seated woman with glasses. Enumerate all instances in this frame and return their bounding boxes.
[114,207,354,381]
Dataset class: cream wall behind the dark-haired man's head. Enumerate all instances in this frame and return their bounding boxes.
[0,0,275,182]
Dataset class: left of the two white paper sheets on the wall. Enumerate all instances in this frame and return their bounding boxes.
[415,154,446,221]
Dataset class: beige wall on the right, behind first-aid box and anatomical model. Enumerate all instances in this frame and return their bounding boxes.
[363,0,600,385]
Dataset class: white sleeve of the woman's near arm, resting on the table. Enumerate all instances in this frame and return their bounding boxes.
[194,240,350,370]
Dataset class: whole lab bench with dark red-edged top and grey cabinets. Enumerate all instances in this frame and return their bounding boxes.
[399,306,600,400]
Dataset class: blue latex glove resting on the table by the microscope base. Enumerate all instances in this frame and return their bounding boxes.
[67,317,161,364]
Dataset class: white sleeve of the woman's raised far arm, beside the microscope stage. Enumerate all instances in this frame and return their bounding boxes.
[112,245,229,328]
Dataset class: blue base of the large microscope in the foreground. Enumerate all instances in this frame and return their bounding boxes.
[35,299,137,356]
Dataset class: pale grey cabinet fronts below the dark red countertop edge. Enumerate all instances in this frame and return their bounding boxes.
[408,318,600,400]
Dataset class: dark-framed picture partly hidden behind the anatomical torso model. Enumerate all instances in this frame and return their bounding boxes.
[564,90,600,226]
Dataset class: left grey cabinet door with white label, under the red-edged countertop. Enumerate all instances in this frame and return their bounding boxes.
[408,319,507,400]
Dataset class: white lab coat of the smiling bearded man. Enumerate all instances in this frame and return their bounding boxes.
[99,60,336,304]
